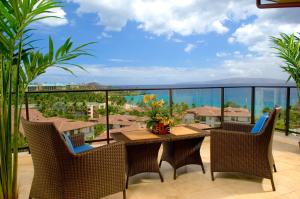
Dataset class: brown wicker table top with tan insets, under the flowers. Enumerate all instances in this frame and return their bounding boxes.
[110,126,210,145]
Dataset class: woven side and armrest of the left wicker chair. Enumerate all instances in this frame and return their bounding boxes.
[64,143,125,198]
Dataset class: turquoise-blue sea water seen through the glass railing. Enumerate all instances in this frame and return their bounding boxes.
[126,88,298,115]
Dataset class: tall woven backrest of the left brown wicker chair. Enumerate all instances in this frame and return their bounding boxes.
[21,118,68,198]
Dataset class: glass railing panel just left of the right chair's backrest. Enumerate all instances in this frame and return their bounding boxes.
[224,88,251,123]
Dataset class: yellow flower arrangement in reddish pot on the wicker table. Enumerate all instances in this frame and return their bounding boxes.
[144,95,173,135]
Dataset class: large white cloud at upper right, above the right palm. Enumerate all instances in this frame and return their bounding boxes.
[228,9,300,55]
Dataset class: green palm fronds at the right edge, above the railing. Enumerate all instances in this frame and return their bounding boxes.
[271,33,300,101]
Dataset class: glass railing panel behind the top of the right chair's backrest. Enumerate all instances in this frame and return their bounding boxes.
[255,87,287,130]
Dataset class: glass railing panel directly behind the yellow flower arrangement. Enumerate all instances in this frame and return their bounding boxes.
[108,90,170,133]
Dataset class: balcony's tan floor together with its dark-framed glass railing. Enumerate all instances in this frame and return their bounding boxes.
[19,86,300,199]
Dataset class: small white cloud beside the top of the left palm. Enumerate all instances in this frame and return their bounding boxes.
[38,8,68,26]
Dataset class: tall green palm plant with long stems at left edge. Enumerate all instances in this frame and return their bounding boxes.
[0,0,90,199]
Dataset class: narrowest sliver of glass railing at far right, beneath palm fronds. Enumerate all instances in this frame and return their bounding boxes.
[290,88,300,133]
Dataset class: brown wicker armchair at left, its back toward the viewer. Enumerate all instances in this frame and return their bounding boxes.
[22,118,126,199]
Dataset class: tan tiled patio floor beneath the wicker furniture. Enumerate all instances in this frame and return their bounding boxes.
[19,133,300,199]
